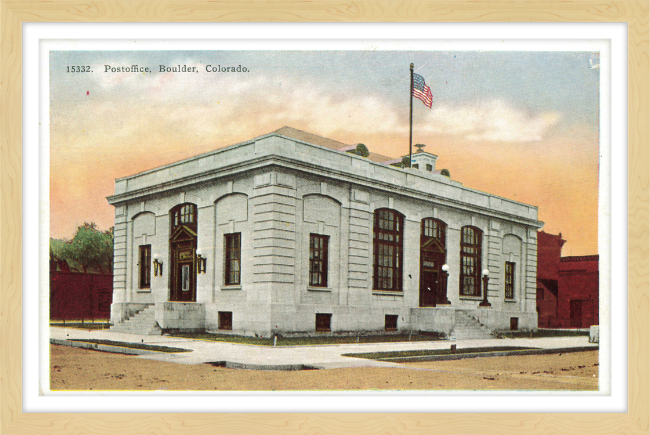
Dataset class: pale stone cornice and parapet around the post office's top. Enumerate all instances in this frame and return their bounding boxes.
[107,133,543,228]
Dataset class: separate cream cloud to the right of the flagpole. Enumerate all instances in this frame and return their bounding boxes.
[424,99,560,142]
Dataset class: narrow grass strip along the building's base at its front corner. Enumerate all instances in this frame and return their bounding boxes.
[170,333,439,346]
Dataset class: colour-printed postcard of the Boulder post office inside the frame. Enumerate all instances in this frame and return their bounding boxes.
[42,41,609,394]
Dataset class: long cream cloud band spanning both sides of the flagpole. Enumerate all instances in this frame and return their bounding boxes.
[62,60,560,142]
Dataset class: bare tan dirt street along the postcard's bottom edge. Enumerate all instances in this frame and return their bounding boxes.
[50,345,598,391]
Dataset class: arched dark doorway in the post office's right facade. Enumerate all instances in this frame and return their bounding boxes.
[420,218,447,307]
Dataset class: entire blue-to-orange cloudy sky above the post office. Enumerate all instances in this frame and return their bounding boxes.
[50,51,600,255]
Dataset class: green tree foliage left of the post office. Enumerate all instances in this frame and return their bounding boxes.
[50,222,113,273]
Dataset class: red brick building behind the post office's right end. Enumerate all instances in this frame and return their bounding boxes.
[537,231,599,328]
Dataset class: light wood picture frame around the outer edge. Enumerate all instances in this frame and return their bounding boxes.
[0,0,650,435]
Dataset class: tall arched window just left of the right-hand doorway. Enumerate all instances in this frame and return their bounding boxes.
[373,209,404,291]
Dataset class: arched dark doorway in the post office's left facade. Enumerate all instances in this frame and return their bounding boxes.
[169,204,197,302]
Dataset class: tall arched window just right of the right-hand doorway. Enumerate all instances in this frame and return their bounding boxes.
[460,227,483,296]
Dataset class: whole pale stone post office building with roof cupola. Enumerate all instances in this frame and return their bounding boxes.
[108,127,542,337]
